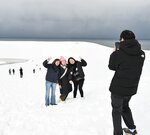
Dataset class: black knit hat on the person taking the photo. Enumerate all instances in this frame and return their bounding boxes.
[120,30,135,40]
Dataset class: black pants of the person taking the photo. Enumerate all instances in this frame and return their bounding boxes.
[111,94,136,135]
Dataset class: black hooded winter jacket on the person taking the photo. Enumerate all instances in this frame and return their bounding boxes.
[108,39,145,96]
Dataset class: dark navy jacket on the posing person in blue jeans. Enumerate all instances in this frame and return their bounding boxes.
[43,60,59,83]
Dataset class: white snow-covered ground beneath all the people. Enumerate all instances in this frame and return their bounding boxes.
[0,41,150,135]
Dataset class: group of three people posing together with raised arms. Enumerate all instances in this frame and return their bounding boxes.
[43,56,87,106]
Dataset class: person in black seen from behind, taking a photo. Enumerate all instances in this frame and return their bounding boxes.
[108,30,145,135]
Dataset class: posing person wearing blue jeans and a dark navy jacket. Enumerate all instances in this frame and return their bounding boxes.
[43,58,60,106]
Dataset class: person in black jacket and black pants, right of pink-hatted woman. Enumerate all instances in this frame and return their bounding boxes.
[68,57,87,98]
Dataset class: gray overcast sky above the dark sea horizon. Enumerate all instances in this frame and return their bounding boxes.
[0,0,150,39]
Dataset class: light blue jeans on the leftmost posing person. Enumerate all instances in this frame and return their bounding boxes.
[45,81,56,106]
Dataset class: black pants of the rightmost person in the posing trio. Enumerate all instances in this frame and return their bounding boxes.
[73,79,84,98]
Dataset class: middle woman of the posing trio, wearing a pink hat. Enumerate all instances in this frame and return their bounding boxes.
[58,56,73,102]
